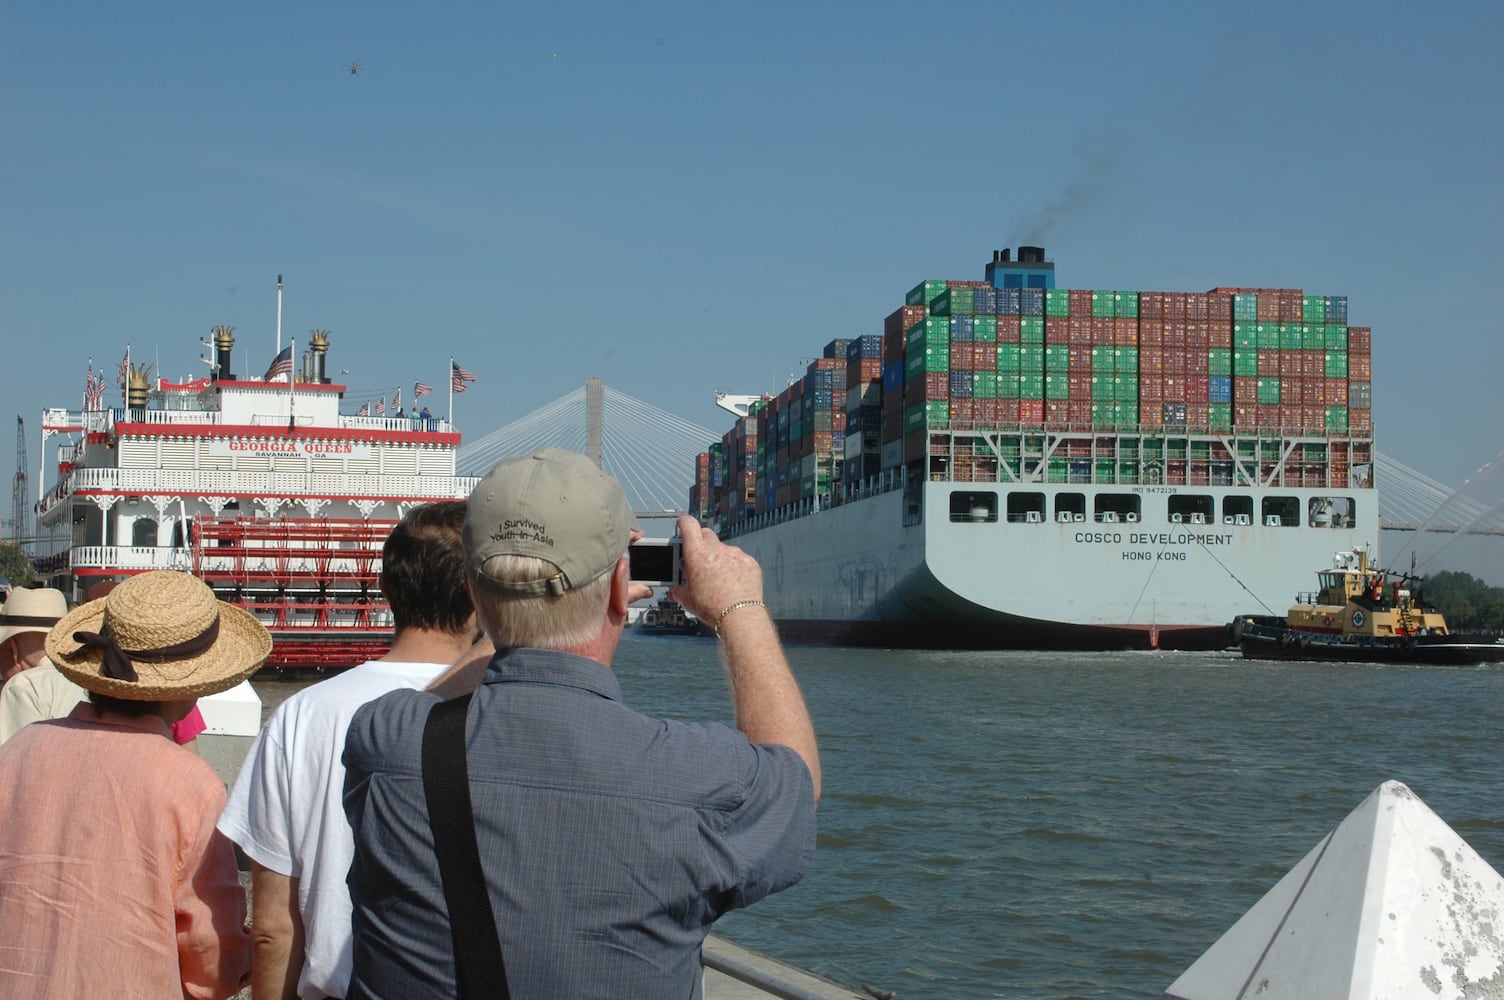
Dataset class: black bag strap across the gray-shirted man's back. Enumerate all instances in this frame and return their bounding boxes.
[423,695,511,1000]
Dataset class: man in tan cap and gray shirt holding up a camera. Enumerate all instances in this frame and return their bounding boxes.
[344,448,820,1000]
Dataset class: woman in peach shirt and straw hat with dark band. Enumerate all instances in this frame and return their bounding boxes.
[0,570,271,998]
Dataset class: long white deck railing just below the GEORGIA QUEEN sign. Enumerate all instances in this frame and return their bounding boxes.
[59,469,480,499]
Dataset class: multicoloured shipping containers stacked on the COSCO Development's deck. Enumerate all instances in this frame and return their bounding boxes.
[692,273,1373,517]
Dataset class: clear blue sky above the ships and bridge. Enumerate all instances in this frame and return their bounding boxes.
[0,3,1504,541]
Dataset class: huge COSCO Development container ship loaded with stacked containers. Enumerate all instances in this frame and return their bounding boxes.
[689,247,1379,650]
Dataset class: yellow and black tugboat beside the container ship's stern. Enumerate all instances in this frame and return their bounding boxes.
[1227,547,1504,665]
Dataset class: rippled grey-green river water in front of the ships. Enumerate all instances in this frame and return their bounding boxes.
[257,633,1504,1000]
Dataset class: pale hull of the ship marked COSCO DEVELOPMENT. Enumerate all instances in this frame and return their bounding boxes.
[731,481,1378,650]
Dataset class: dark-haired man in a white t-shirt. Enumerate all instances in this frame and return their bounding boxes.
[218,501,478,1000]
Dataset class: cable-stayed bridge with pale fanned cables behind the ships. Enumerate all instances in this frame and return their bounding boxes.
[459,379,1504,547]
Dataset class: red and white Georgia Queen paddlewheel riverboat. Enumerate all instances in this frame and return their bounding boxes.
[33,326,475,668]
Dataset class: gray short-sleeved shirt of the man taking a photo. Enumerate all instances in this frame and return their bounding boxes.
[344,650,815,1000]
